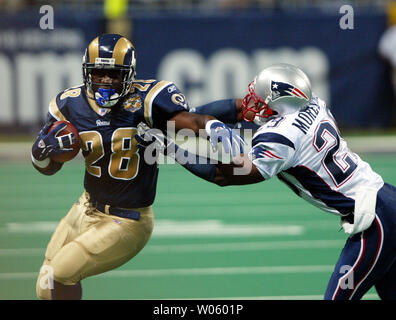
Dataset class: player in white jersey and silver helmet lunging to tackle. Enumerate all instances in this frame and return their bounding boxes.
[140,64,396,300]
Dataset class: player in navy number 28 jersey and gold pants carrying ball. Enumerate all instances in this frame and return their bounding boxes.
[31,34,243,299]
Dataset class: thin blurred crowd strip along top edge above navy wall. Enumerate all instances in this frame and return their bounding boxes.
[0,0,395,11]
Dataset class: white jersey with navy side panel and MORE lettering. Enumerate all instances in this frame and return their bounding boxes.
[249,97,384,215]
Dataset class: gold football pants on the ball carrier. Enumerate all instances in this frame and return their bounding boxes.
[36,192,154,299]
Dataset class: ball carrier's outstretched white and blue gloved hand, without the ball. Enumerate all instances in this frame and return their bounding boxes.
[205,120,247,157]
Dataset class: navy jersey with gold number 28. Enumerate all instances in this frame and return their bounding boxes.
[47,80,188,208]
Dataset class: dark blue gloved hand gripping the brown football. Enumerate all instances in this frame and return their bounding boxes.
[32,123,74,161]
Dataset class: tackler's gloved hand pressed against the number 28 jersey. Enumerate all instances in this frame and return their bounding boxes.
[135,122,175,155]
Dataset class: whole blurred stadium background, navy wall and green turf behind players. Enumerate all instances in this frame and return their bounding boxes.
[0,0,396,299]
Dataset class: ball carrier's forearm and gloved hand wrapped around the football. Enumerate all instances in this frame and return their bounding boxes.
[31,123,74,175]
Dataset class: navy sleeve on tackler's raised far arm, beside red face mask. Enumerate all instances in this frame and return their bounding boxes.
[190,99,237,123]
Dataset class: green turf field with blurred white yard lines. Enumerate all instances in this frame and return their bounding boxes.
[0,154,396,299]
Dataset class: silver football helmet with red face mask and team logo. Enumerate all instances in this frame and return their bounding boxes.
[242,63,312,125]
